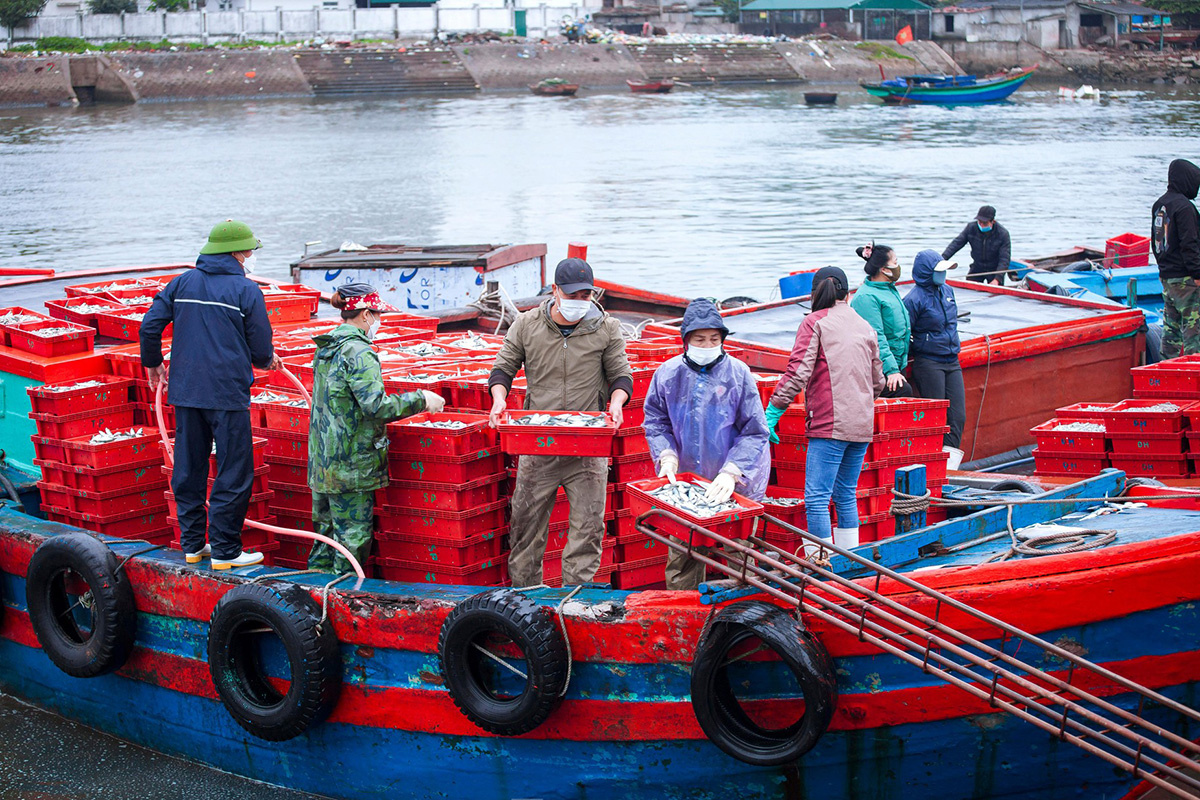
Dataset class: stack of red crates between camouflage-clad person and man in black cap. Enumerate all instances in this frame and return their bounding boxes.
[376,413,508,585]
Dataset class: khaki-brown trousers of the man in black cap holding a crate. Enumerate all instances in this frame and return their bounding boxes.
[509,456,608,587]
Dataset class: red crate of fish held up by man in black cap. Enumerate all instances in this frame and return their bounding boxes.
[497,411,617,456]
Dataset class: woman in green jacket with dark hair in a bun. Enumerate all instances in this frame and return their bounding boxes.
[850,242,912,397]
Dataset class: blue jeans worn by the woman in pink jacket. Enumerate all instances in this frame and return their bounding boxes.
[804,439,869,539]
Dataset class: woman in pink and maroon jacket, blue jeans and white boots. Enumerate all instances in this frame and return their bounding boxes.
[767,266,886,547]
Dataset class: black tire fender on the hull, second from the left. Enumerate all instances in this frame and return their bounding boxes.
[209,583,342,741]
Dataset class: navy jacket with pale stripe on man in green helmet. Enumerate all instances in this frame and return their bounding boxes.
[142,253,275,411]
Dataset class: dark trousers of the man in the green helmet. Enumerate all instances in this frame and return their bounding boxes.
[170,405,254,559]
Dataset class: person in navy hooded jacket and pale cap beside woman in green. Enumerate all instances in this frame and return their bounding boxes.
[904,249,967,457]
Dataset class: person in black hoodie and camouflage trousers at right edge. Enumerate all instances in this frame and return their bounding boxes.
[1150,158,1200,359]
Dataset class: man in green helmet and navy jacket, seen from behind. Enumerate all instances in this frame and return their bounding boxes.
[142,219,280,570]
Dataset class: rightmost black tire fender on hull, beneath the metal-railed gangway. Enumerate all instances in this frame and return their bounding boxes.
[691,601,838,766]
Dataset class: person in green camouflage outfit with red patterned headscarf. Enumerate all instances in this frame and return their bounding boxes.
[308,283,445,575]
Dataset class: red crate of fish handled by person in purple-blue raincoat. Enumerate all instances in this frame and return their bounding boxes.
[625,473,763,547]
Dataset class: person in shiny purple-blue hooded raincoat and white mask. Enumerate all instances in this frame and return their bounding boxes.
[642,299,770,589]
